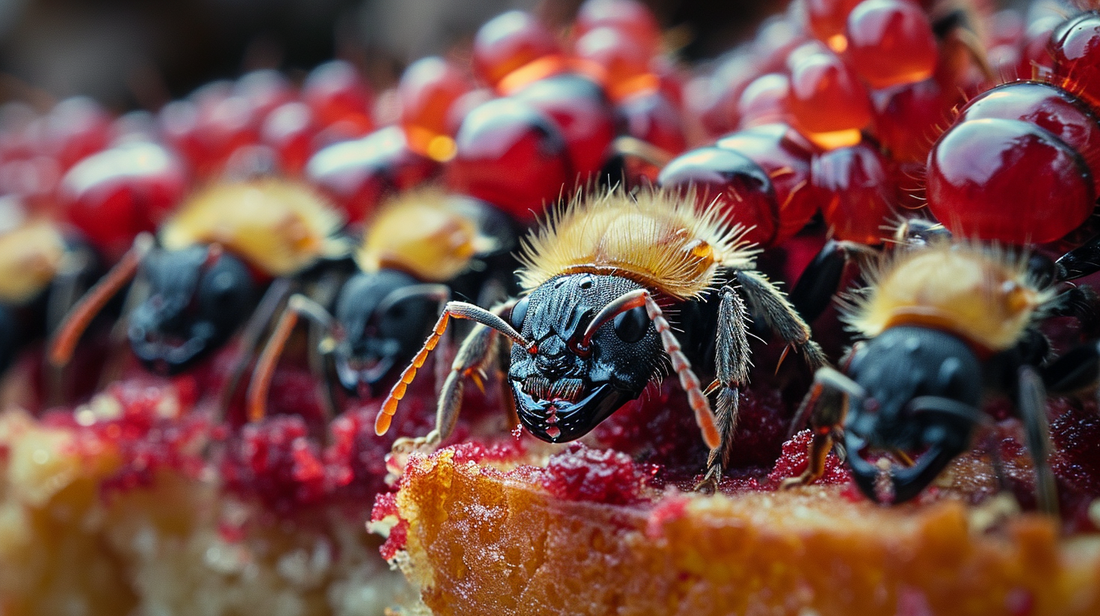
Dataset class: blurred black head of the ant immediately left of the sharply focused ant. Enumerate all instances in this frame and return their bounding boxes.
[334,270,446,396]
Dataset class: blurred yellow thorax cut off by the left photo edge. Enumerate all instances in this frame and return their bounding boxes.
[0,220,66,305]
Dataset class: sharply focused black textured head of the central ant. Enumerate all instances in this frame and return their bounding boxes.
[508,274,667,442]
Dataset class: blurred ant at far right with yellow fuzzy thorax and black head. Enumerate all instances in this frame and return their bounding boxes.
[783,237,1100,514]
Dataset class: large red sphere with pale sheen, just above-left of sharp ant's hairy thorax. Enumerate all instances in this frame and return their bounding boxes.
[446,98,573,221]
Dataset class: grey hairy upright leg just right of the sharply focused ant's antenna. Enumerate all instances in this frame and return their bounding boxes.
[695,286,751,492]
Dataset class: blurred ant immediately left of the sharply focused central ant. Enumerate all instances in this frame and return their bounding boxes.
[248,188,515,420]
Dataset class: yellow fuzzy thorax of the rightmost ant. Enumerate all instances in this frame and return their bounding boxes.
[845,242,1053,351]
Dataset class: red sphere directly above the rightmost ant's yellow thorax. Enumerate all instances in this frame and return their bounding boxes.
[811,142,894,245]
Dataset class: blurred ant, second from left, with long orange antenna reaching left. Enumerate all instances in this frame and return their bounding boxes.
[50,177,348,407]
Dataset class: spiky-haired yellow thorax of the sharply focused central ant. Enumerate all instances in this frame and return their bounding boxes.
[518,190,755,299]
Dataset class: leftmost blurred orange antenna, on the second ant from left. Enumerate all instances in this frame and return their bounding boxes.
[48,233,154,367]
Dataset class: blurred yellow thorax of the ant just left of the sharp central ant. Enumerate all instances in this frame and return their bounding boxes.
[355,189,496,282]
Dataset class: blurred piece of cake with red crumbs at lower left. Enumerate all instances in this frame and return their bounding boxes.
[0,411,407,616]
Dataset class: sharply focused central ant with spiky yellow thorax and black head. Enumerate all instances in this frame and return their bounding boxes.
[375,190,827,490]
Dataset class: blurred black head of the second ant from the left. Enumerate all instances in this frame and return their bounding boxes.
[129,246,259,374]
